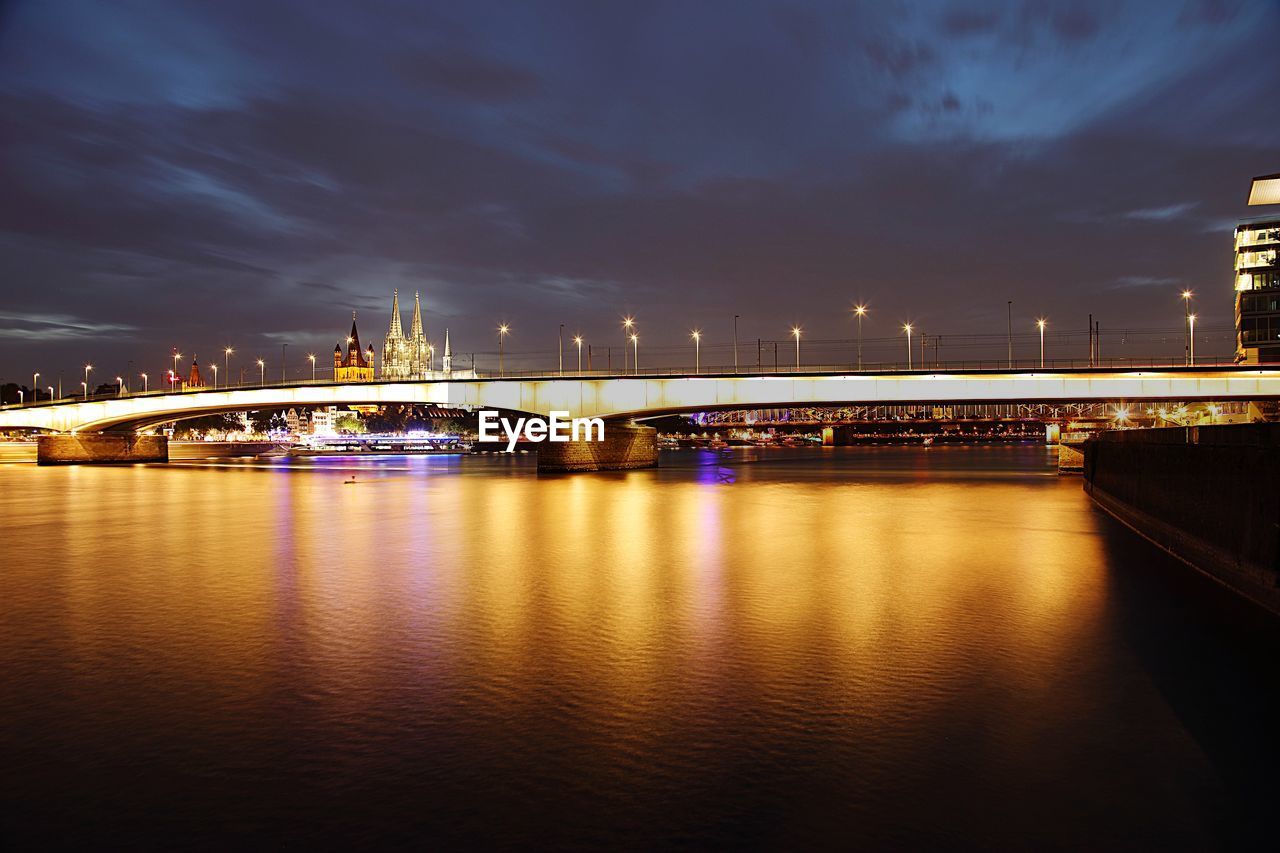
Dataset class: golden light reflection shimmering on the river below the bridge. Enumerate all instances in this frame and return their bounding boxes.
[0,448,1218,845]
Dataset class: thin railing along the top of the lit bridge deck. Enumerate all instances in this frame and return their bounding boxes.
[0,356,1259,409]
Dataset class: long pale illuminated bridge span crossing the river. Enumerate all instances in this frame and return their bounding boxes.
[0,365,1280,461]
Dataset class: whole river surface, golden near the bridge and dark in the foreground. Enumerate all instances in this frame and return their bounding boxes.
[0,446,1280,849]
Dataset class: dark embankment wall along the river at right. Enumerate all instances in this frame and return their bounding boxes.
[1084,424,1280,613]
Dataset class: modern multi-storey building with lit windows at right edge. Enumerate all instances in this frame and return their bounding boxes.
[1235,174,1280,364]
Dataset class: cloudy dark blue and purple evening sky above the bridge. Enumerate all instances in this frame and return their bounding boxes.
[0,0,1280,386]
